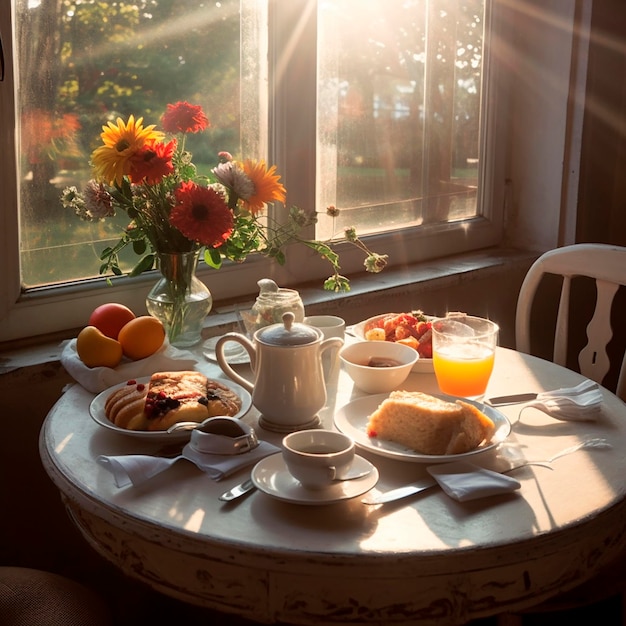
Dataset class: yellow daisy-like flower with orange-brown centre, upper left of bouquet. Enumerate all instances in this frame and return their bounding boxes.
[91,115,164,185]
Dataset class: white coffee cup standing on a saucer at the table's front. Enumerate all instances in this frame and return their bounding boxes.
[283,429,354,489]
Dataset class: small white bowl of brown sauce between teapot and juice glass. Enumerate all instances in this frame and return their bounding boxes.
[339,341,419,393]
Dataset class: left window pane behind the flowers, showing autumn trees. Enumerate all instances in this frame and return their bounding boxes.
[16,0,246,287]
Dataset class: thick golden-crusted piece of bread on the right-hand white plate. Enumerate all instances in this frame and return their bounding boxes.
[367,391,495,455]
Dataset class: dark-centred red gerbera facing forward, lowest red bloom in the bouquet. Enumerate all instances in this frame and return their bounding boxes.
[170,181,233,248]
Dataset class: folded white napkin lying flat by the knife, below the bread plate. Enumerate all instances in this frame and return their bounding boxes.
[426,461,521,502]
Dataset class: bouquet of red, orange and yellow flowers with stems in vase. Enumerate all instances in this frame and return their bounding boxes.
[61,102,387,345]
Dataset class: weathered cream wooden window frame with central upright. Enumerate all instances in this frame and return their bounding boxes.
[0,0,528,341]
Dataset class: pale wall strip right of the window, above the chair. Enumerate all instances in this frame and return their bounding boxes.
[503,0,592,251]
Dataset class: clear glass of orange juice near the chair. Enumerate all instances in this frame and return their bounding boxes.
[432,313,499,400]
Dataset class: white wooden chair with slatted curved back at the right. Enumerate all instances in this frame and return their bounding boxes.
[515,243,626,400]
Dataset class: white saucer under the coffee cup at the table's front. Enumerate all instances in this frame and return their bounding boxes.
[252,453,378,505]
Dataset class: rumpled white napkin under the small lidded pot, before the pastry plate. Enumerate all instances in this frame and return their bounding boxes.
[96,441,280,487]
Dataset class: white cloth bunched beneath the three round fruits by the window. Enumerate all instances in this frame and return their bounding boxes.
[61,339,197,393]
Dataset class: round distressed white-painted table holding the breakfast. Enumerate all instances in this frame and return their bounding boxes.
[40,349,626,625]
